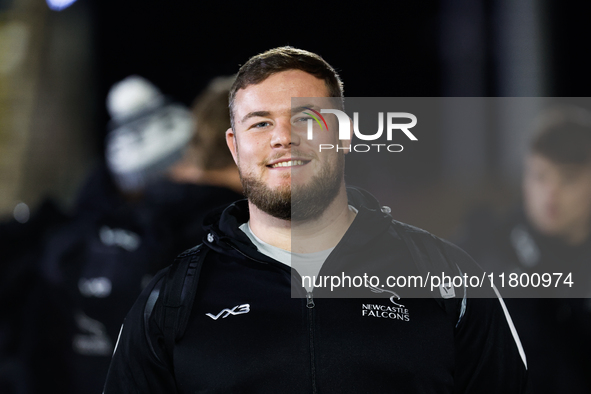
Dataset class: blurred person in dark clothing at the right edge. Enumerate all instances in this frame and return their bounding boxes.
[459,106,591,394]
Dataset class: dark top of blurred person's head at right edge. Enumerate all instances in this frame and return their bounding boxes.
[530,105,591,165]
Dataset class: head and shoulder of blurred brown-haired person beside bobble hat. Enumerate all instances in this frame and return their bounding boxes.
[153,76,244,256]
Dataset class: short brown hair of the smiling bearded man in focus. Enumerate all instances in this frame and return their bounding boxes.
[230,46,343,128]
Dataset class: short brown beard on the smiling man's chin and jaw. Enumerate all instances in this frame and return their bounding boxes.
[238,153,345,221]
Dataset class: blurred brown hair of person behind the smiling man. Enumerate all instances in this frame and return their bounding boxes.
[191,75,236,170]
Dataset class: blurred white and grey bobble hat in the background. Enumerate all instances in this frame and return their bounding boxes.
[105,75,194,191]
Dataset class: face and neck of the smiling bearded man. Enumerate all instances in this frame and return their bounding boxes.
[226,70,355,252]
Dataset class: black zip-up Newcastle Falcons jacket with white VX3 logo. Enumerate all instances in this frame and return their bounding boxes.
[105,189,526,394]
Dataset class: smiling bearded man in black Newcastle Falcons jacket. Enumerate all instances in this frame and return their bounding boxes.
[105,47,526,394]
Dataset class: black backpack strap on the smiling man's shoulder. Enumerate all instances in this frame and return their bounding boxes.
[160,245,209,363]
